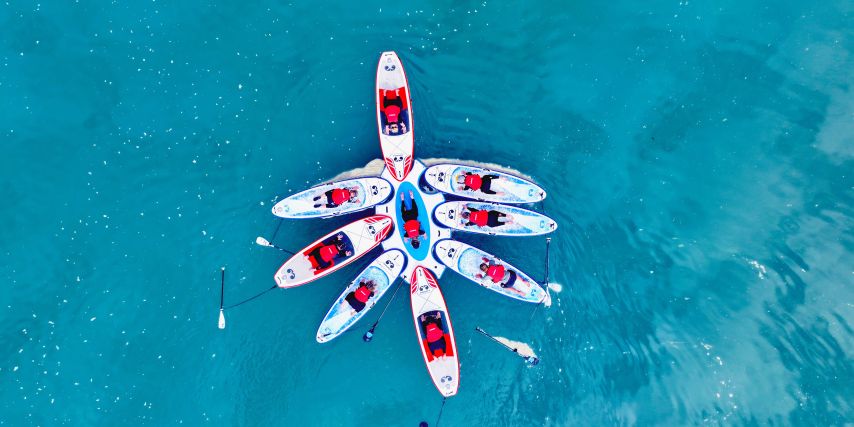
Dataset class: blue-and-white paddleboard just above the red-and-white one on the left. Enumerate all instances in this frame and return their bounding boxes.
[273,177,393,218]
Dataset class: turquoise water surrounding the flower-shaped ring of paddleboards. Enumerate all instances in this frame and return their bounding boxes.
[0,1,854,426]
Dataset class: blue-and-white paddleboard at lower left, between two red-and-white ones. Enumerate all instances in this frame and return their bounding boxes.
[317,249,406,343]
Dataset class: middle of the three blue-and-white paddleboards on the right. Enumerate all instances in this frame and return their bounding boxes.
[433,201,557,236]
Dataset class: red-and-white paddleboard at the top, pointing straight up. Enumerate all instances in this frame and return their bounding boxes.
[376,52,414,181]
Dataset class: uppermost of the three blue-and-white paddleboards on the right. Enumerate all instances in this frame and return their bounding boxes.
[424,163,546,203]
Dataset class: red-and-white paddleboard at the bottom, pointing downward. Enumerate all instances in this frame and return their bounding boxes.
[409,266,460,397]
